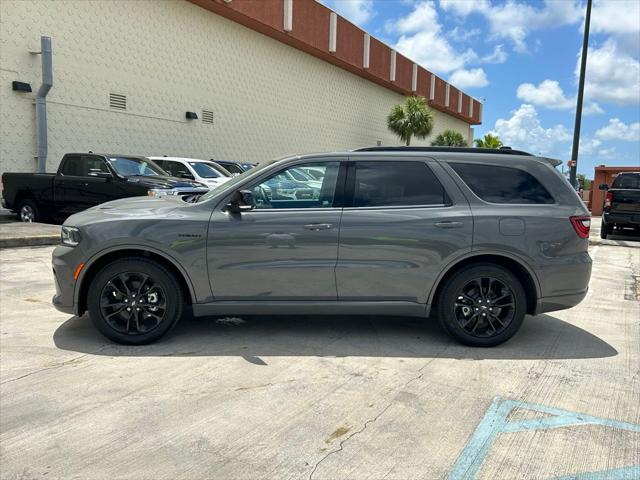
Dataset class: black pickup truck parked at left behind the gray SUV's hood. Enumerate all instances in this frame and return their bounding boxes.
[2,153,208,222]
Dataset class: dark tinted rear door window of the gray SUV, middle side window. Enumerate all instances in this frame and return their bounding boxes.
[353,161,449,207]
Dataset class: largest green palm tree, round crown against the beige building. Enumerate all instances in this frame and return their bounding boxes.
[387,96,433,146]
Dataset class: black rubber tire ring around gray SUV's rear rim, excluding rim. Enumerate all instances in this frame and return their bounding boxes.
[437,264,527,347]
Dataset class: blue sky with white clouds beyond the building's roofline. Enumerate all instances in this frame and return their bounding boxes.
[321,0,640,178]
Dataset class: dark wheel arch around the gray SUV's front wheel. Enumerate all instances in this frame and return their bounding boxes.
[74,246,196,316]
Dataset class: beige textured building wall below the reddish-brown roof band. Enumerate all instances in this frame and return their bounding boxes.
[0,0,471,172]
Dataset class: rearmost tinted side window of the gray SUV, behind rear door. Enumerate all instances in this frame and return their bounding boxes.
[450,163,555,204]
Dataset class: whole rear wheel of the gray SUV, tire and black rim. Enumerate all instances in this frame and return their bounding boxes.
[436,264,527,347]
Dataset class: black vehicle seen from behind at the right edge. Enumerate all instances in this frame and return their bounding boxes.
[598,172,640,238]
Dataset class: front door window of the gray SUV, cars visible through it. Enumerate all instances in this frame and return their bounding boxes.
[251,162,340,209]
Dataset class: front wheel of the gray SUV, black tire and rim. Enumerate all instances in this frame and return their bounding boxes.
[87,258,184,345]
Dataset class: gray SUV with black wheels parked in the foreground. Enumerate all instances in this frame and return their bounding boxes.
[53,147,591,346]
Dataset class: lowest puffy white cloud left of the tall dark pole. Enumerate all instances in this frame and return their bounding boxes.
[491,103,571,154]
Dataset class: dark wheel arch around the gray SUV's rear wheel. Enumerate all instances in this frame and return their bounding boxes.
[427,252,540,315]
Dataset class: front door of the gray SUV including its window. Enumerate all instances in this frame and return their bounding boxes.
[207,161,344,301]
